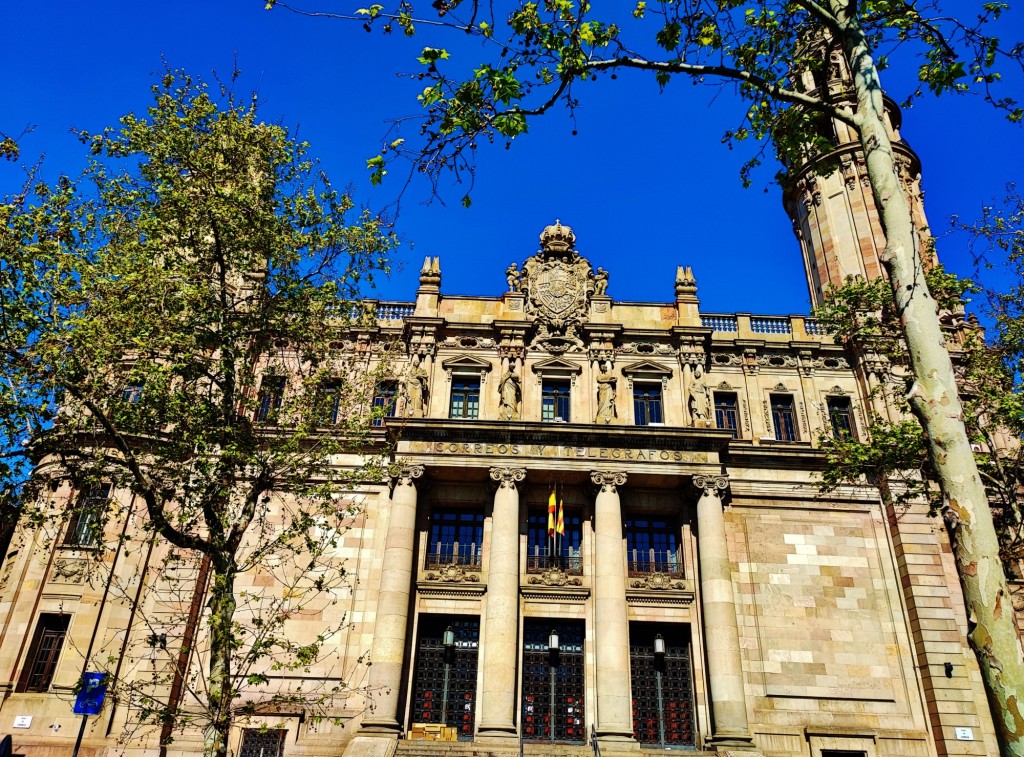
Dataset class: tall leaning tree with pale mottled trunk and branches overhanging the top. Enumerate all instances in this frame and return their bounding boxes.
[267,0,1024,755]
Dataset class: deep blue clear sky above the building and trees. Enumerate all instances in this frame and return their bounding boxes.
[0,0,1024,313]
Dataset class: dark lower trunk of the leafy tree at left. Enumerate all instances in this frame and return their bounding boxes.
[203,559,236,757]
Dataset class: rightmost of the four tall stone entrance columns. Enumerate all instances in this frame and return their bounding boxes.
[693,475,753,748]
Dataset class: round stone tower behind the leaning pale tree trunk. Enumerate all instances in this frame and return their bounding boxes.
[783,39,929,307]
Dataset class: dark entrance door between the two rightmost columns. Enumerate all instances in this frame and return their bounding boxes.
[630,623,693,747]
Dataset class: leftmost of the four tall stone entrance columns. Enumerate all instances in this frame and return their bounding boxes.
[360,465,423,735]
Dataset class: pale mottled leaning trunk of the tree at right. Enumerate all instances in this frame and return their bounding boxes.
[831,5,1024,757]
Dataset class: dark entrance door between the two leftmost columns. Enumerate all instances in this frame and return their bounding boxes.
[410,615,480,741]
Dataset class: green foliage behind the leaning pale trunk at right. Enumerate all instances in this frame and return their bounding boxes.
[815,266,1024,578]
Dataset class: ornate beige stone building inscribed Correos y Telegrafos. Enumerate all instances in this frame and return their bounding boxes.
[0,62,997,757]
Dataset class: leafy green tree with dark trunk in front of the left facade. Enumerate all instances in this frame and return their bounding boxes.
[0,72,394,755]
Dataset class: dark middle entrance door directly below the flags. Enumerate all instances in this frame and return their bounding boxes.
[522,619,586,744]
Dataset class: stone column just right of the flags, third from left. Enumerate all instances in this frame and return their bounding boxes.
[590,470,633,742]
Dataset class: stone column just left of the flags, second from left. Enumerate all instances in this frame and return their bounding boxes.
[477,468,526,739]
